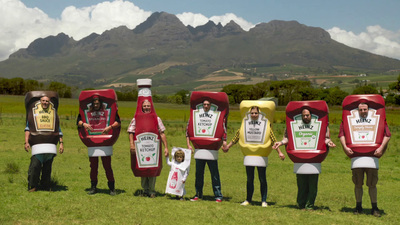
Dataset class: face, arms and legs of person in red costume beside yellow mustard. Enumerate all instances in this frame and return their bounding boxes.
[186,100,226,202]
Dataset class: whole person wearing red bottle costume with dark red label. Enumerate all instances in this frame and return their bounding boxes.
[77,89,121,195]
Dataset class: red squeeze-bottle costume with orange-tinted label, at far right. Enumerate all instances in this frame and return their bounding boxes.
[342,94,386,169]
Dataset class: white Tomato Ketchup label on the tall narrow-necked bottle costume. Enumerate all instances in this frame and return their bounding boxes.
[135,132,160,168]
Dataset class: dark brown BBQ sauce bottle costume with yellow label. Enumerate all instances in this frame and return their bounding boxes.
[25,91,60,155]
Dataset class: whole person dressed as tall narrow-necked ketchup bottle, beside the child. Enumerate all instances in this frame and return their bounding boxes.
[127,79,169,198]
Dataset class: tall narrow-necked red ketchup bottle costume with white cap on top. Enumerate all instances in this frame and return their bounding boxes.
[131,79,163,177]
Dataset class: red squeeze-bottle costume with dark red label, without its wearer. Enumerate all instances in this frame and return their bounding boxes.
[78,89,121,157]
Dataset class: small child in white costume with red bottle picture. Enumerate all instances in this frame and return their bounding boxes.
[165,148,192,200]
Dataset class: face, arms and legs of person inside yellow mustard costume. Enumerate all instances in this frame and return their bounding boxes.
[224,106,285,207]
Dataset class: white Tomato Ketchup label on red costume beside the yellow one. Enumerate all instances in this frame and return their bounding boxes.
[193,103,221,138]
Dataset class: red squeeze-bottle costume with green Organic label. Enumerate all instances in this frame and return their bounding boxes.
[286,101,329,174]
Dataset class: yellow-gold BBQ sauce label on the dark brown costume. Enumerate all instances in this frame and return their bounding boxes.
[32,101,56,132]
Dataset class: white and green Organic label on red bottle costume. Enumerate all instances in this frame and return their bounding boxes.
[290,114,321,150]
